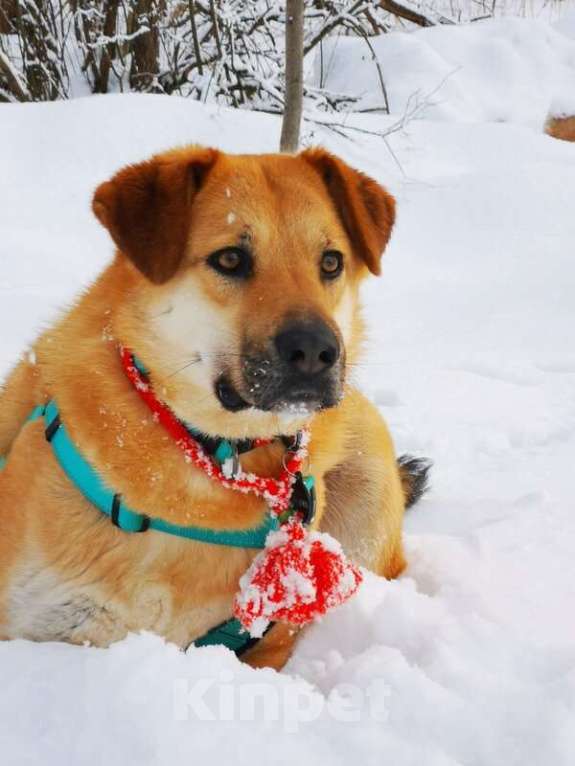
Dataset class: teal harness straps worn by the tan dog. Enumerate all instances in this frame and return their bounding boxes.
[0,401,314,656]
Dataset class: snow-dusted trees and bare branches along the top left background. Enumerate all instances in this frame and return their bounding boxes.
[0,0,450,106]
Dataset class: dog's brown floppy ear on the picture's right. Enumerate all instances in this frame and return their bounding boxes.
[299,148,395,274]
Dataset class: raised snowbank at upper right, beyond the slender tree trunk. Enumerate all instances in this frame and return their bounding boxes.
[314,14,575,129]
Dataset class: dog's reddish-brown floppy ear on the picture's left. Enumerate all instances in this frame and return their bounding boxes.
[92,147,219,284]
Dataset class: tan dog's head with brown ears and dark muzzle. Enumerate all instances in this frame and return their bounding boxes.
[93,147,394,436]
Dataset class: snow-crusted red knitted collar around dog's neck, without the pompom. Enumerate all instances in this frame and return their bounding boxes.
[120,348,310,515]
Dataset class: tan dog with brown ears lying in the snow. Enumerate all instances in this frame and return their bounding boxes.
[0,146,427,669]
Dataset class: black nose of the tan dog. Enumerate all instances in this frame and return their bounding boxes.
[275,321,339,375]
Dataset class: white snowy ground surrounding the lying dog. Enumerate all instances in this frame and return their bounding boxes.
[0,15,575,766]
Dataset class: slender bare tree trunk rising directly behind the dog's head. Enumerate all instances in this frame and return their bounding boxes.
[280,0,303,152]
